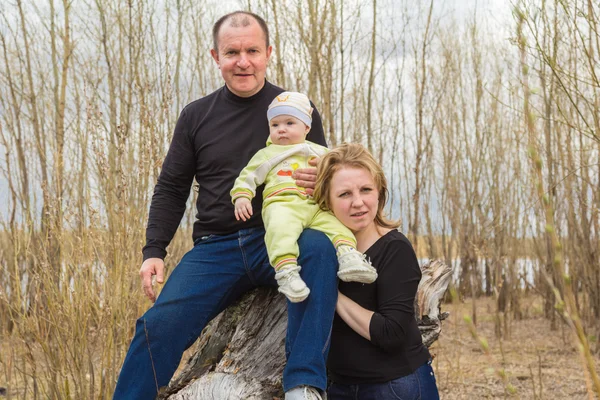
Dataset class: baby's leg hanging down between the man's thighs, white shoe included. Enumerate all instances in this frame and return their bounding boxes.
[262,201,310,303]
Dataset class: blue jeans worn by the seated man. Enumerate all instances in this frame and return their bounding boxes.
[114,228,337,399]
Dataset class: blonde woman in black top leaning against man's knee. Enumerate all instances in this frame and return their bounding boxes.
[314,144,439,400]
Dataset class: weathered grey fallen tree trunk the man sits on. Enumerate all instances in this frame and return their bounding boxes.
[159,260,451,400]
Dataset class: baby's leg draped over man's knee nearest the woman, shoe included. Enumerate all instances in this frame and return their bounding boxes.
[310,210,377,283]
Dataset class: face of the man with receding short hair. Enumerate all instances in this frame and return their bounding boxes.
[210,16,271,97]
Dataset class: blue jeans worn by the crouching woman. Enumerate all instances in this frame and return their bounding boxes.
[327,362,440,400]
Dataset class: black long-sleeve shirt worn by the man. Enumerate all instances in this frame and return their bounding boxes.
[143,82,326,260]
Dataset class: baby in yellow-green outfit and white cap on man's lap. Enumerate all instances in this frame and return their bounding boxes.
[231,92,377,303]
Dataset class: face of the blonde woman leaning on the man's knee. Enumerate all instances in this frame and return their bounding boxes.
[329,167,379,234]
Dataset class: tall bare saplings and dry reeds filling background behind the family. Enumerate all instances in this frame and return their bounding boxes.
[0,0,600,399]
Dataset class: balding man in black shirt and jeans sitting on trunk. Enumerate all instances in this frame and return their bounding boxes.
[114,12,337,400]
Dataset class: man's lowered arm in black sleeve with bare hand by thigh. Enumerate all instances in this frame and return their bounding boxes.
[140,109,196,301]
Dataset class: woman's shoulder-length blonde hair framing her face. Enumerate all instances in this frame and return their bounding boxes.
[313,143,399,228]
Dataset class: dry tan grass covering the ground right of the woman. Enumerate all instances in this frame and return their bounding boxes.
[431,296,600,400]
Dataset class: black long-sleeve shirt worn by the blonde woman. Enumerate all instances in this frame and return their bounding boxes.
[327,230,430,384]
